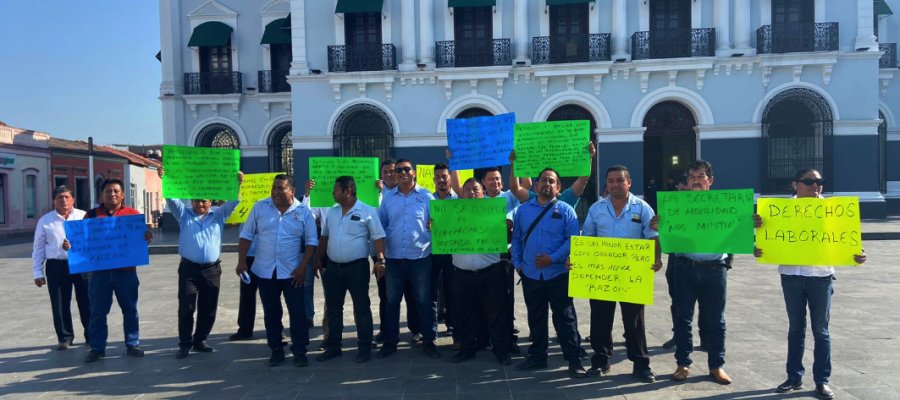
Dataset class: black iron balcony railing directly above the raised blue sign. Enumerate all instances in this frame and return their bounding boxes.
[434,39,512,68]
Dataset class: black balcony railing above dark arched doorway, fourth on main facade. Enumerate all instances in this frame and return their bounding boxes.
[631,28,716,60]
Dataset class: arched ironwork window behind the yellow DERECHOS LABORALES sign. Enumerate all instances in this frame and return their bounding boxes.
[762,88,834,193]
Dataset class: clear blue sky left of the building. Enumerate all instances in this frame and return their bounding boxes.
[0,0,162,144]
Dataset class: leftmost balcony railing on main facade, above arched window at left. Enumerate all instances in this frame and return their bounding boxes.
[328,44,397,72]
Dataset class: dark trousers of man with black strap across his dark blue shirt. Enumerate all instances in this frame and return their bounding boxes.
[522,273,581,361]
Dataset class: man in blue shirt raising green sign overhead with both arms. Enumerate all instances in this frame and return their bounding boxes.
[157,167,244,358]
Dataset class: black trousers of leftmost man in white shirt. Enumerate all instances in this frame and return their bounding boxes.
[45,260,91,343]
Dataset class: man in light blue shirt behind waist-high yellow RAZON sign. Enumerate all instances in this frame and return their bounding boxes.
[582,165,662,383]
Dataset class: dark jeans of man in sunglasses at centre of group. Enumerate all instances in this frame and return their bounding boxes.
[382,256,437,346]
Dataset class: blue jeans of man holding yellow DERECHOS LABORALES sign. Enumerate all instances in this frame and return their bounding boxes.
[781,275,834,385]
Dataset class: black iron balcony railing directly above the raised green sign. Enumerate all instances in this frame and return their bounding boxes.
[531,33,609,64]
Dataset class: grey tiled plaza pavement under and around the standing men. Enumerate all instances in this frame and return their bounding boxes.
[0,241,900,400]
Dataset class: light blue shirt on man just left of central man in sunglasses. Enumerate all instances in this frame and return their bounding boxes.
[322,200,384,263]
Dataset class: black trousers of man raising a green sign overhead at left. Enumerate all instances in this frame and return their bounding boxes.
[178,258,222,348]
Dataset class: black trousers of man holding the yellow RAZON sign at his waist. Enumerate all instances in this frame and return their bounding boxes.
[591,300,650,371]
